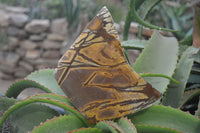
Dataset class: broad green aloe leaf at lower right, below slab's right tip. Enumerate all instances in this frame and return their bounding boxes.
[128,105,200,133]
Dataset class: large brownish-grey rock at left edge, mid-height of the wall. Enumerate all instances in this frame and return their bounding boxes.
[0,52,20,67]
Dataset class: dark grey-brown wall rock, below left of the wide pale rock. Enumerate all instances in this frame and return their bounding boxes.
[6,27,27,39]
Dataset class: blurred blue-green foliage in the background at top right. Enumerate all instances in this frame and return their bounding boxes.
[158,3,193,39]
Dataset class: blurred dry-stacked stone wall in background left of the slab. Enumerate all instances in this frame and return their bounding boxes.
[0,7,67,79]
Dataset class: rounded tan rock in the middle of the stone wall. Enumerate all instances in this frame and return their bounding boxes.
[20,40,39,50]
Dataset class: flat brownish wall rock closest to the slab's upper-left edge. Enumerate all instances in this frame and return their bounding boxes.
[42,50,60,59]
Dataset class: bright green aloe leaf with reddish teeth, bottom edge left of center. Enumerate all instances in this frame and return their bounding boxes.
[31,115,85,133]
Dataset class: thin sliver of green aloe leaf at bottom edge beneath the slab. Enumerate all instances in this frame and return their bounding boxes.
[71,127,105,133]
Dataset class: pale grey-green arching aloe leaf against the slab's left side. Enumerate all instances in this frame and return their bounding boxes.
[5,69,66,98]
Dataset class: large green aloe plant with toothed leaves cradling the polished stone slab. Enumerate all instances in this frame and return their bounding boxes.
[0,1,200,133]
